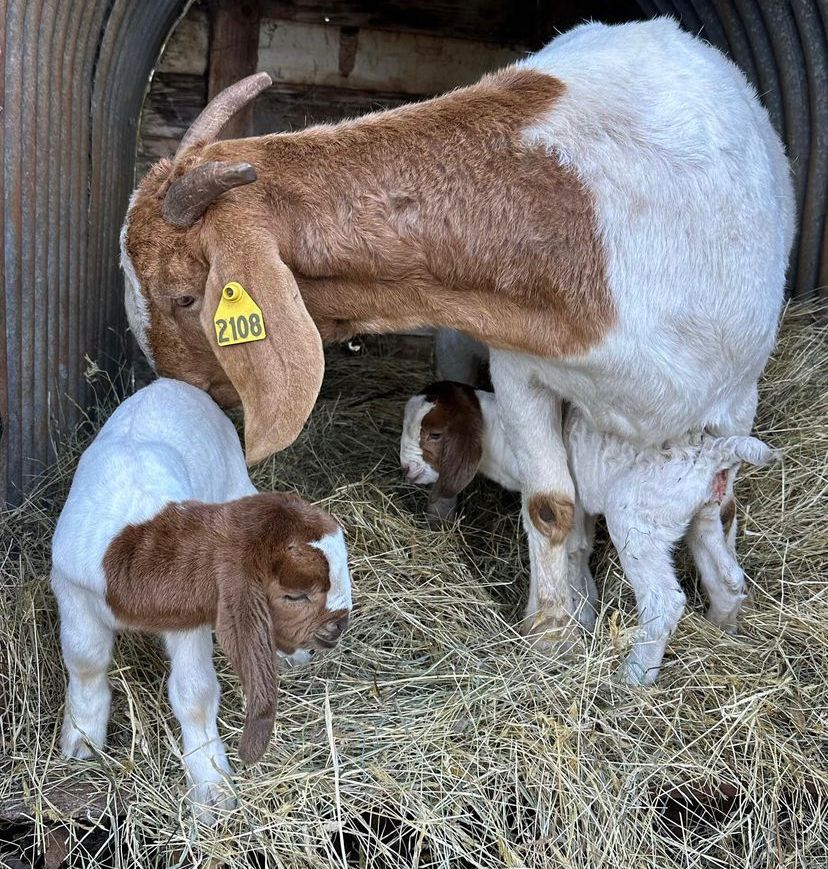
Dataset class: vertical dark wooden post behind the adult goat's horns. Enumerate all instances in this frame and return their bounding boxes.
[207,0,262,139]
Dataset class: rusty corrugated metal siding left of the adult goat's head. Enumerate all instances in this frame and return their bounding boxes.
[0,0,184,503]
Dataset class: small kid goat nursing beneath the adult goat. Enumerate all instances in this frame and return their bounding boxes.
[400,381,778,683]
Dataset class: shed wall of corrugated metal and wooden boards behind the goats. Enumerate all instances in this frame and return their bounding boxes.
[0,0,828,503]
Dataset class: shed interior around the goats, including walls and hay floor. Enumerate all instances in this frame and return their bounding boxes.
[0,0,828,867]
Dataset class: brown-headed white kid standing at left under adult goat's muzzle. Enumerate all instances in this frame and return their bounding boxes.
[51,379,351,822]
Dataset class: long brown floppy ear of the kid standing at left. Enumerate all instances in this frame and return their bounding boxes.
[216,579,279,763]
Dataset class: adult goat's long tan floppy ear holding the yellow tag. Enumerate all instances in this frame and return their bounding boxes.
[201,230,325,465]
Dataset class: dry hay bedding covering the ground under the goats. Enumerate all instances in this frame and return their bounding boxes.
[0,312,828,869]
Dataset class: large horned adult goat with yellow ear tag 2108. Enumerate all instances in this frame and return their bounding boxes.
[121,19,794,652]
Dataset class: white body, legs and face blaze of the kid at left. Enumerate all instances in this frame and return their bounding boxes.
[51,379,350,822]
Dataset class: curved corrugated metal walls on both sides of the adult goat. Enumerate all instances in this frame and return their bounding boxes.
[0,0,828,503]
